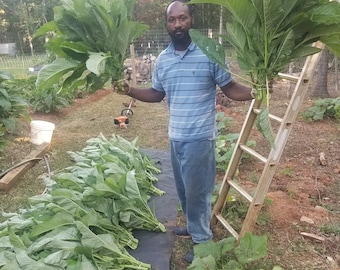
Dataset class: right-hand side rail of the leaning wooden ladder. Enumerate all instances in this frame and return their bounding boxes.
[239,43,324,238]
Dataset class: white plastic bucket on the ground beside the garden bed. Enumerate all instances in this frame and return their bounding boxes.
[30,120,55,145]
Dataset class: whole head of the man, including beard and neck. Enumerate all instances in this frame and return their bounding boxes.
[165,0,194,50]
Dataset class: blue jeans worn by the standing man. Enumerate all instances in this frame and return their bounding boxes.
[170,140,216,243]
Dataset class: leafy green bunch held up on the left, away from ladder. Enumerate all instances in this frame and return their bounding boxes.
[35,0,148,93]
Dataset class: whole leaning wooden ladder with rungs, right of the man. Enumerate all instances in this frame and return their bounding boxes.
[211,42,324,240]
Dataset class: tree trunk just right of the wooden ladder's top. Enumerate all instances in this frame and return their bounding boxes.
[311,47,330,98]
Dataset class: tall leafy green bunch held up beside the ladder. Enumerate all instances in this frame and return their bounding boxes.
[190,0,340,147]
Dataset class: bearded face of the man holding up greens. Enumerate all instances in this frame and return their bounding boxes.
[166,2,192,43]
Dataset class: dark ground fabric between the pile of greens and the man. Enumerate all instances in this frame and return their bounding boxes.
[129,149,179,270]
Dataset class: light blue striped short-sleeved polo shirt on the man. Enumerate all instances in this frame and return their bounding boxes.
[152,42,232,141]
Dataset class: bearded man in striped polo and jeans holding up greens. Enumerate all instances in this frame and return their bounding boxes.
[117,0,252,263]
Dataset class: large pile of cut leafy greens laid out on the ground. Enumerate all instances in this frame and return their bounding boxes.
[0,134,165,270]
